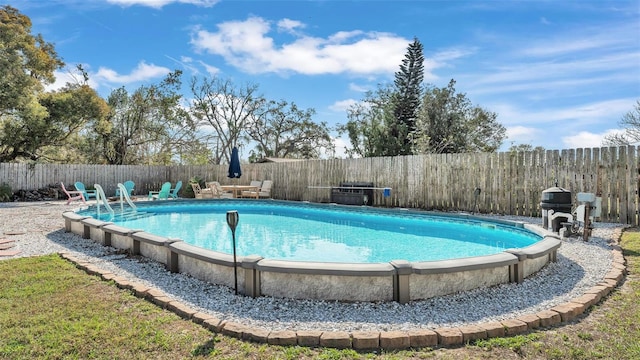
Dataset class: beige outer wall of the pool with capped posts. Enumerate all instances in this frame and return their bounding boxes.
[63,211,560,303]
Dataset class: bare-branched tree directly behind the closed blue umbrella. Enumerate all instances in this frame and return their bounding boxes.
[190,78,266,164]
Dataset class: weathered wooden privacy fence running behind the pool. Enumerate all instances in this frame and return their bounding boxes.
[0,146,640,225]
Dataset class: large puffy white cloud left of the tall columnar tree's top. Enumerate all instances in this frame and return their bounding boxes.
[191,17,416,78]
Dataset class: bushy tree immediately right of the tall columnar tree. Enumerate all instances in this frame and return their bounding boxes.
[413,80,506,153]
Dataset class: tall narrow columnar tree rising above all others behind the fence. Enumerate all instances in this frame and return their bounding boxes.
[390,38,424,155]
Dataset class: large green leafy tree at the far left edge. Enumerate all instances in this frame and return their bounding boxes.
[0,6,107,162]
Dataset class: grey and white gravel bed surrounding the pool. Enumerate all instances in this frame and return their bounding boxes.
[0,202,624,331]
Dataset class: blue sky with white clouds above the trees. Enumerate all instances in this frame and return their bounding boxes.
[8,0,640,155]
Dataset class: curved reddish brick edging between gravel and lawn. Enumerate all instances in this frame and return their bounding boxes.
[59,230,626,350]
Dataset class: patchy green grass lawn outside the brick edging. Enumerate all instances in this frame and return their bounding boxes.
[0,229,640,360]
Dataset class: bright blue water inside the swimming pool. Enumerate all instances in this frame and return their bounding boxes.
[80,200,541,263]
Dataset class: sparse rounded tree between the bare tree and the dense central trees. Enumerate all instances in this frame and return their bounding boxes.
[246,100,334,161]
